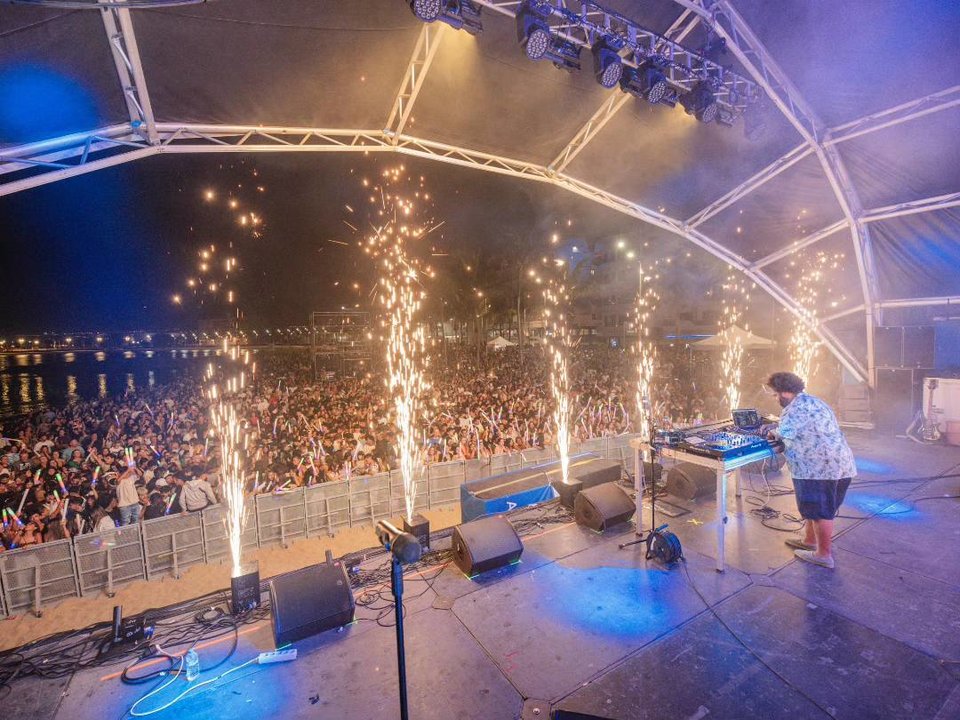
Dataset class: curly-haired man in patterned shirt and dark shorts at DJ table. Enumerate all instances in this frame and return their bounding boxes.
[764,372,857,568]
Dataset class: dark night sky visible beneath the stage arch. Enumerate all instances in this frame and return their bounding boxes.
[0,154,705,332]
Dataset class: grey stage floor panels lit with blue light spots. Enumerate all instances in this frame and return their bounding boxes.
[4,434,960,720]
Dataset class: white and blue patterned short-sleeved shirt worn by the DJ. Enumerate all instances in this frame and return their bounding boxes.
[776,393,857,480]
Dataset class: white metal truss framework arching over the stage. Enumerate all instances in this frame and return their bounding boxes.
[0,0,960,382]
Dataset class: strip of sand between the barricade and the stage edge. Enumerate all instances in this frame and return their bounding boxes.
[0,504,460,650]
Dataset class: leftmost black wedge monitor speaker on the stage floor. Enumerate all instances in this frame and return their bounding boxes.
[270,562,356,647]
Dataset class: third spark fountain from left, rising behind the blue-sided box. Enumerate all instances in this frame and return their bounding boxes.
[543,282,573,483]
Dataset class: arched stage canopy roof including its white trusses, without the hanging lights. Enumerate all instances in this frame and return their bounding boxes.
[0,0,960,382]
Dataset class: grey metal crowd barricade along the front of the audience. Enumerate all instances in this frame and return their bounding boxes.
[0,435,635,616]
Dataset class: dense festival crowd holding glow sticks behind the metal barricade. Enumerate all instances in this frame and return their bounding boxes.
[0,347,736,549]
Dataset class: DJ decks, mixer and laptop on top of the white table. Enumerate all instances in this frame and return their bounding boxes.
[654,409,779,460]
